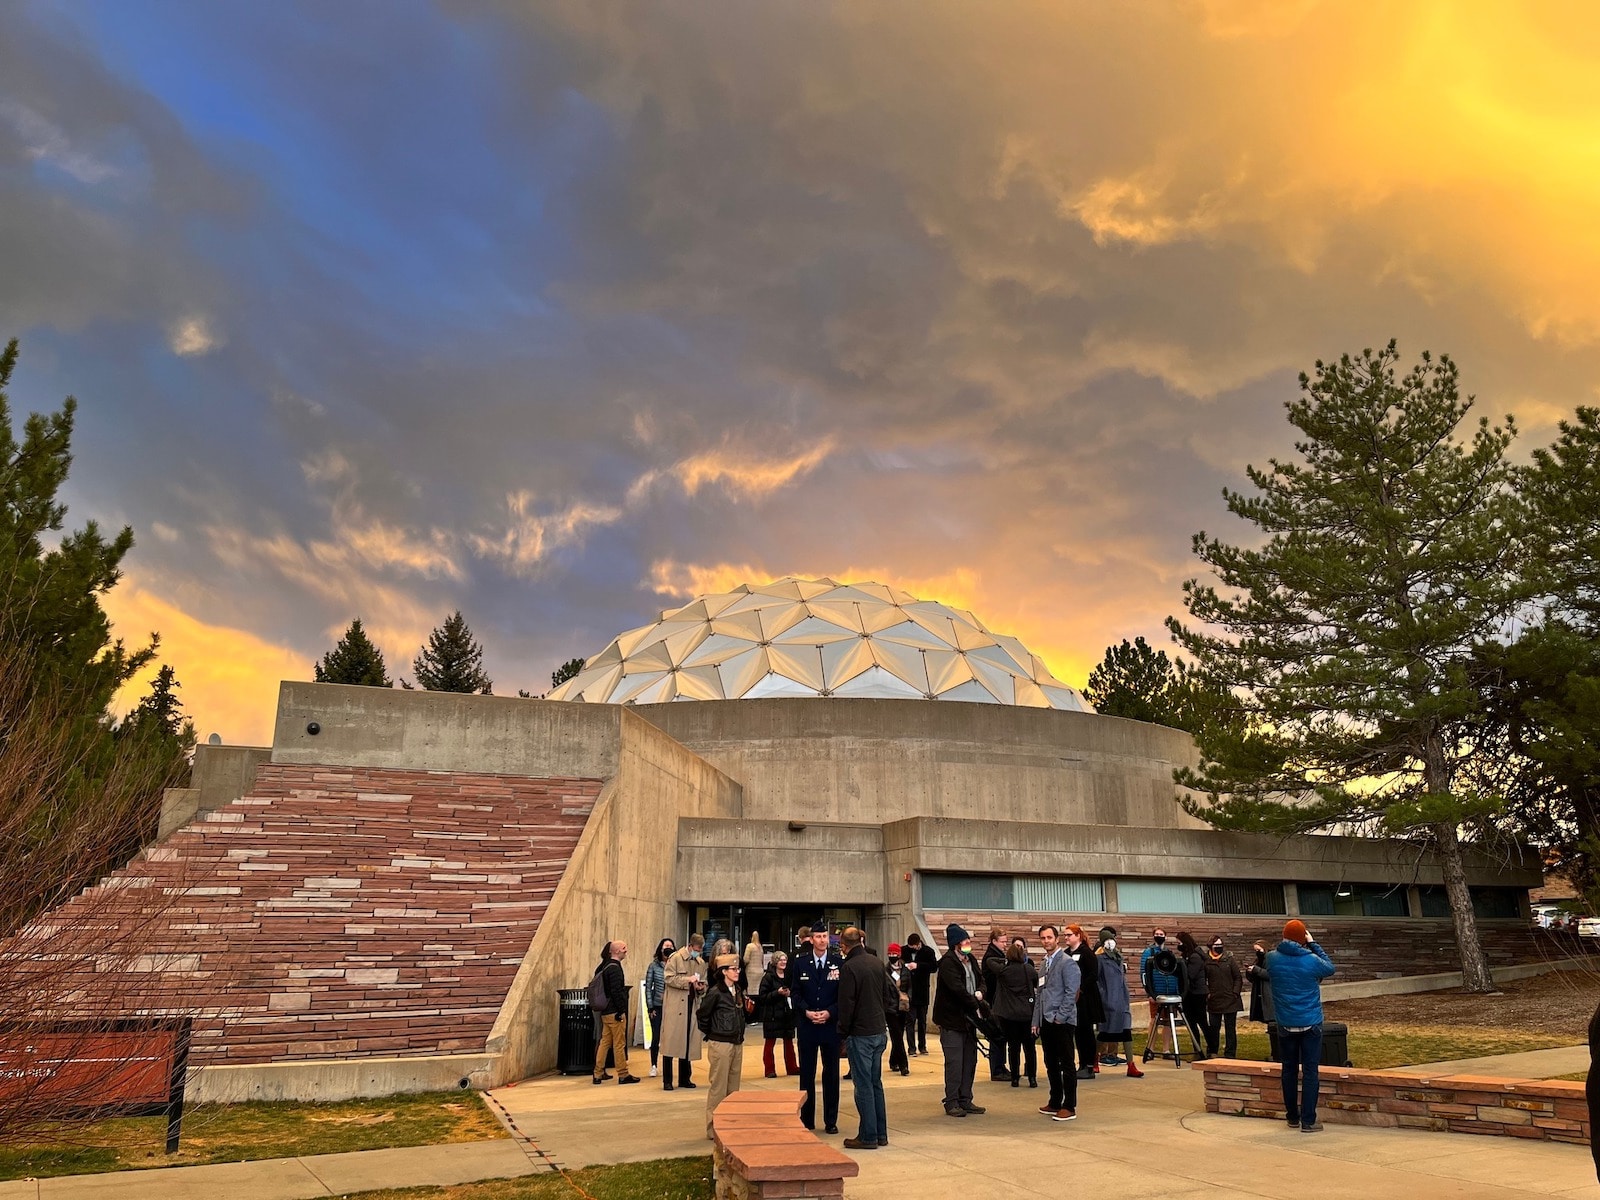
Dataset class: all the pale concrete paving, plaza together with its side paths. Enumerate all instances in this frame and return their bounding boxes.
[9,1042,1600,1200]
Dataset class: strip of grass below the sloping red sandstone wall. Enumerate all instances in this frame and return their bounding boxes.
[0,1091,506,1179]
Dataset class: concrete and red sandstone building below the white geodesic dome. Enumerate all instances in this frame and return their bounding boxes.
[28,581,1565,1099]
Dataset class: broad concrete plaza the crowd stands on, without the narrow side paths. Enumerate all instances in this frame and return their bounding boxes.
[494,1043,1600,1200]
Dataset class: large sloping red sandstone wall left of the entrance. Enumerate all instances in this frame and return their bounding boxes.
[31,765,602,1062]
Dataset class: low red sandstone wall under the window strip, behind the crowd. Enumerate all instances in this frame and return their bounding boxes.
[925,912,1600,989]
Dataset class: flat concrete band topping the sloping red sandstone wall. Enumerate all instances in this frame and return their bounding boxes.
[272,682,622,779]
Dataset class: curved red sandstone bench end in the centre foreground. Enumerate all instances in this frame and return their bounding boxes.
[710,1091,861,1200]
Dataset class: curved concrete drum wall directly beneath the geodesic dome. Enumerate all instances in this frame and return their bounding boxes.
[634,698,1200,829]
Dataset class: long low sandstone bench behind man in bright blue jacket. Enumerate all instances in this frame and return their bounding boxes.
[1194,1058,1589,1146]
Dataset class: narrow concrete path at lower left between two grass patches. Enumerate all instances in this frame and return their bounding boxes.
[0,1138,547,1200]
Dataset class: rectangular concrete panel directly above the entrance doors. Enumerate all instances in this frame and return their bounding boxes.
[677,818,883,904]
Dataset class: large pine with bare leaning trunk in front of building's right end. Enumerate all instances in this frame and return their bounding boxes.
[1168,342,1526,992]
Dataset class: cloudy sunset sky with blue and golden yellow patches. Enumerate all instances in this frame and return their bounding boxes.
[0,0,1600,742]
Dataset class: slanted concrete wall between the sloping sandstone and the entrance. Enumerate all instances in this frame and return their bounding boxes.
[486,701,742,1086]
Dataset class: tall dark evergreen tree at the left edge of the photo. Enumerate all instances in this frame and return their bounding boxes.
[0,341,192,936]
